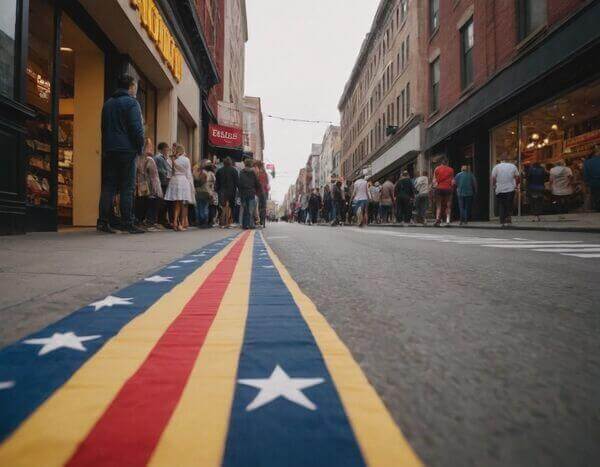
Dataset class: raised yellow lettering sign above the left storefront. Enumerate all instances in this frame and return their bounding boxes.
[130,0,183,82]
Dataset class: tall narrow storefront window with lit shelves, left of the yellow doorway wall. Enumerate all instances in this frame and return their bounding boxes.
[25,0,55,206]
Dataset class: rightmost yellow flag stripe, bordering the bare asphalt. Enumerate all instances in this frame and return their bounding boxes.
[265,236,422,467]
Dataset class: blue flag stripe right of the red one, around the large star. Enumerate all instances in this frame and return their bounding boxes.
[223,236,365,467]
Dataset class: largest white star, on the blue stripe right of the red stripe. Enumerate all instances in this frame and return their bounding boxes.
[238,365,325,412]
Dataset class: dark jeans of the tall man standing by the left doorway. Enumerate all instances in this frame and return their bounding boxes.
[98,152,136,228]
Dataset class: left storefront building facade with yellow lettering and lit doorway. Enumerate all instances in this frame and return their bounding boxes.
[0,0,218,233]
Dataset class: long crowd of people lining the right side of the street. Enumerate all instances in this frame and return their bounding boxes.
[285,145,600,227]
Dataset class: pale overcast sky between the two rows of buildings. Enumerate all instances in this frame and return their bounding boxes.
[245,0,379,202]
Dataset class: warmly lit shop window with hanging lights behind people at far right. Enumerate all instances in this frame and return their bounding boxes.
[491,81,600,215]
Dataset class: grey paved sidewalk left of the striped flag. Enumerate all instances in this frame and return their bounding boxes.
[0,228,232,347]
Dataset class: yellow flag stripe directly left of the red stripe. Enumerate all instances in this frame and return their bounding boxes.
[0,238,245,467]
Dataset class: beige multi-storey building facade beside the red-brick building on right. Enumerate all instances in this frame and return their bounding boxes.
[338,0,426,186]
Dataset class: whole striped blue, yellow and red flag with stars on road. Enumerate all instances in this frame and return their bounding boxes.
[0,233,419,467]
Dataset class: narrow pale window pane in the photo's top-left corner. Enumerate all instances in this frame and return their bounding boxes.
[0,0,17,97]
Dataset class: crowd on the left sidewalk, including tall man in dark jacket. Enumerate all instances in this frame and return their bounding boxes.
[97,76,270,234]
